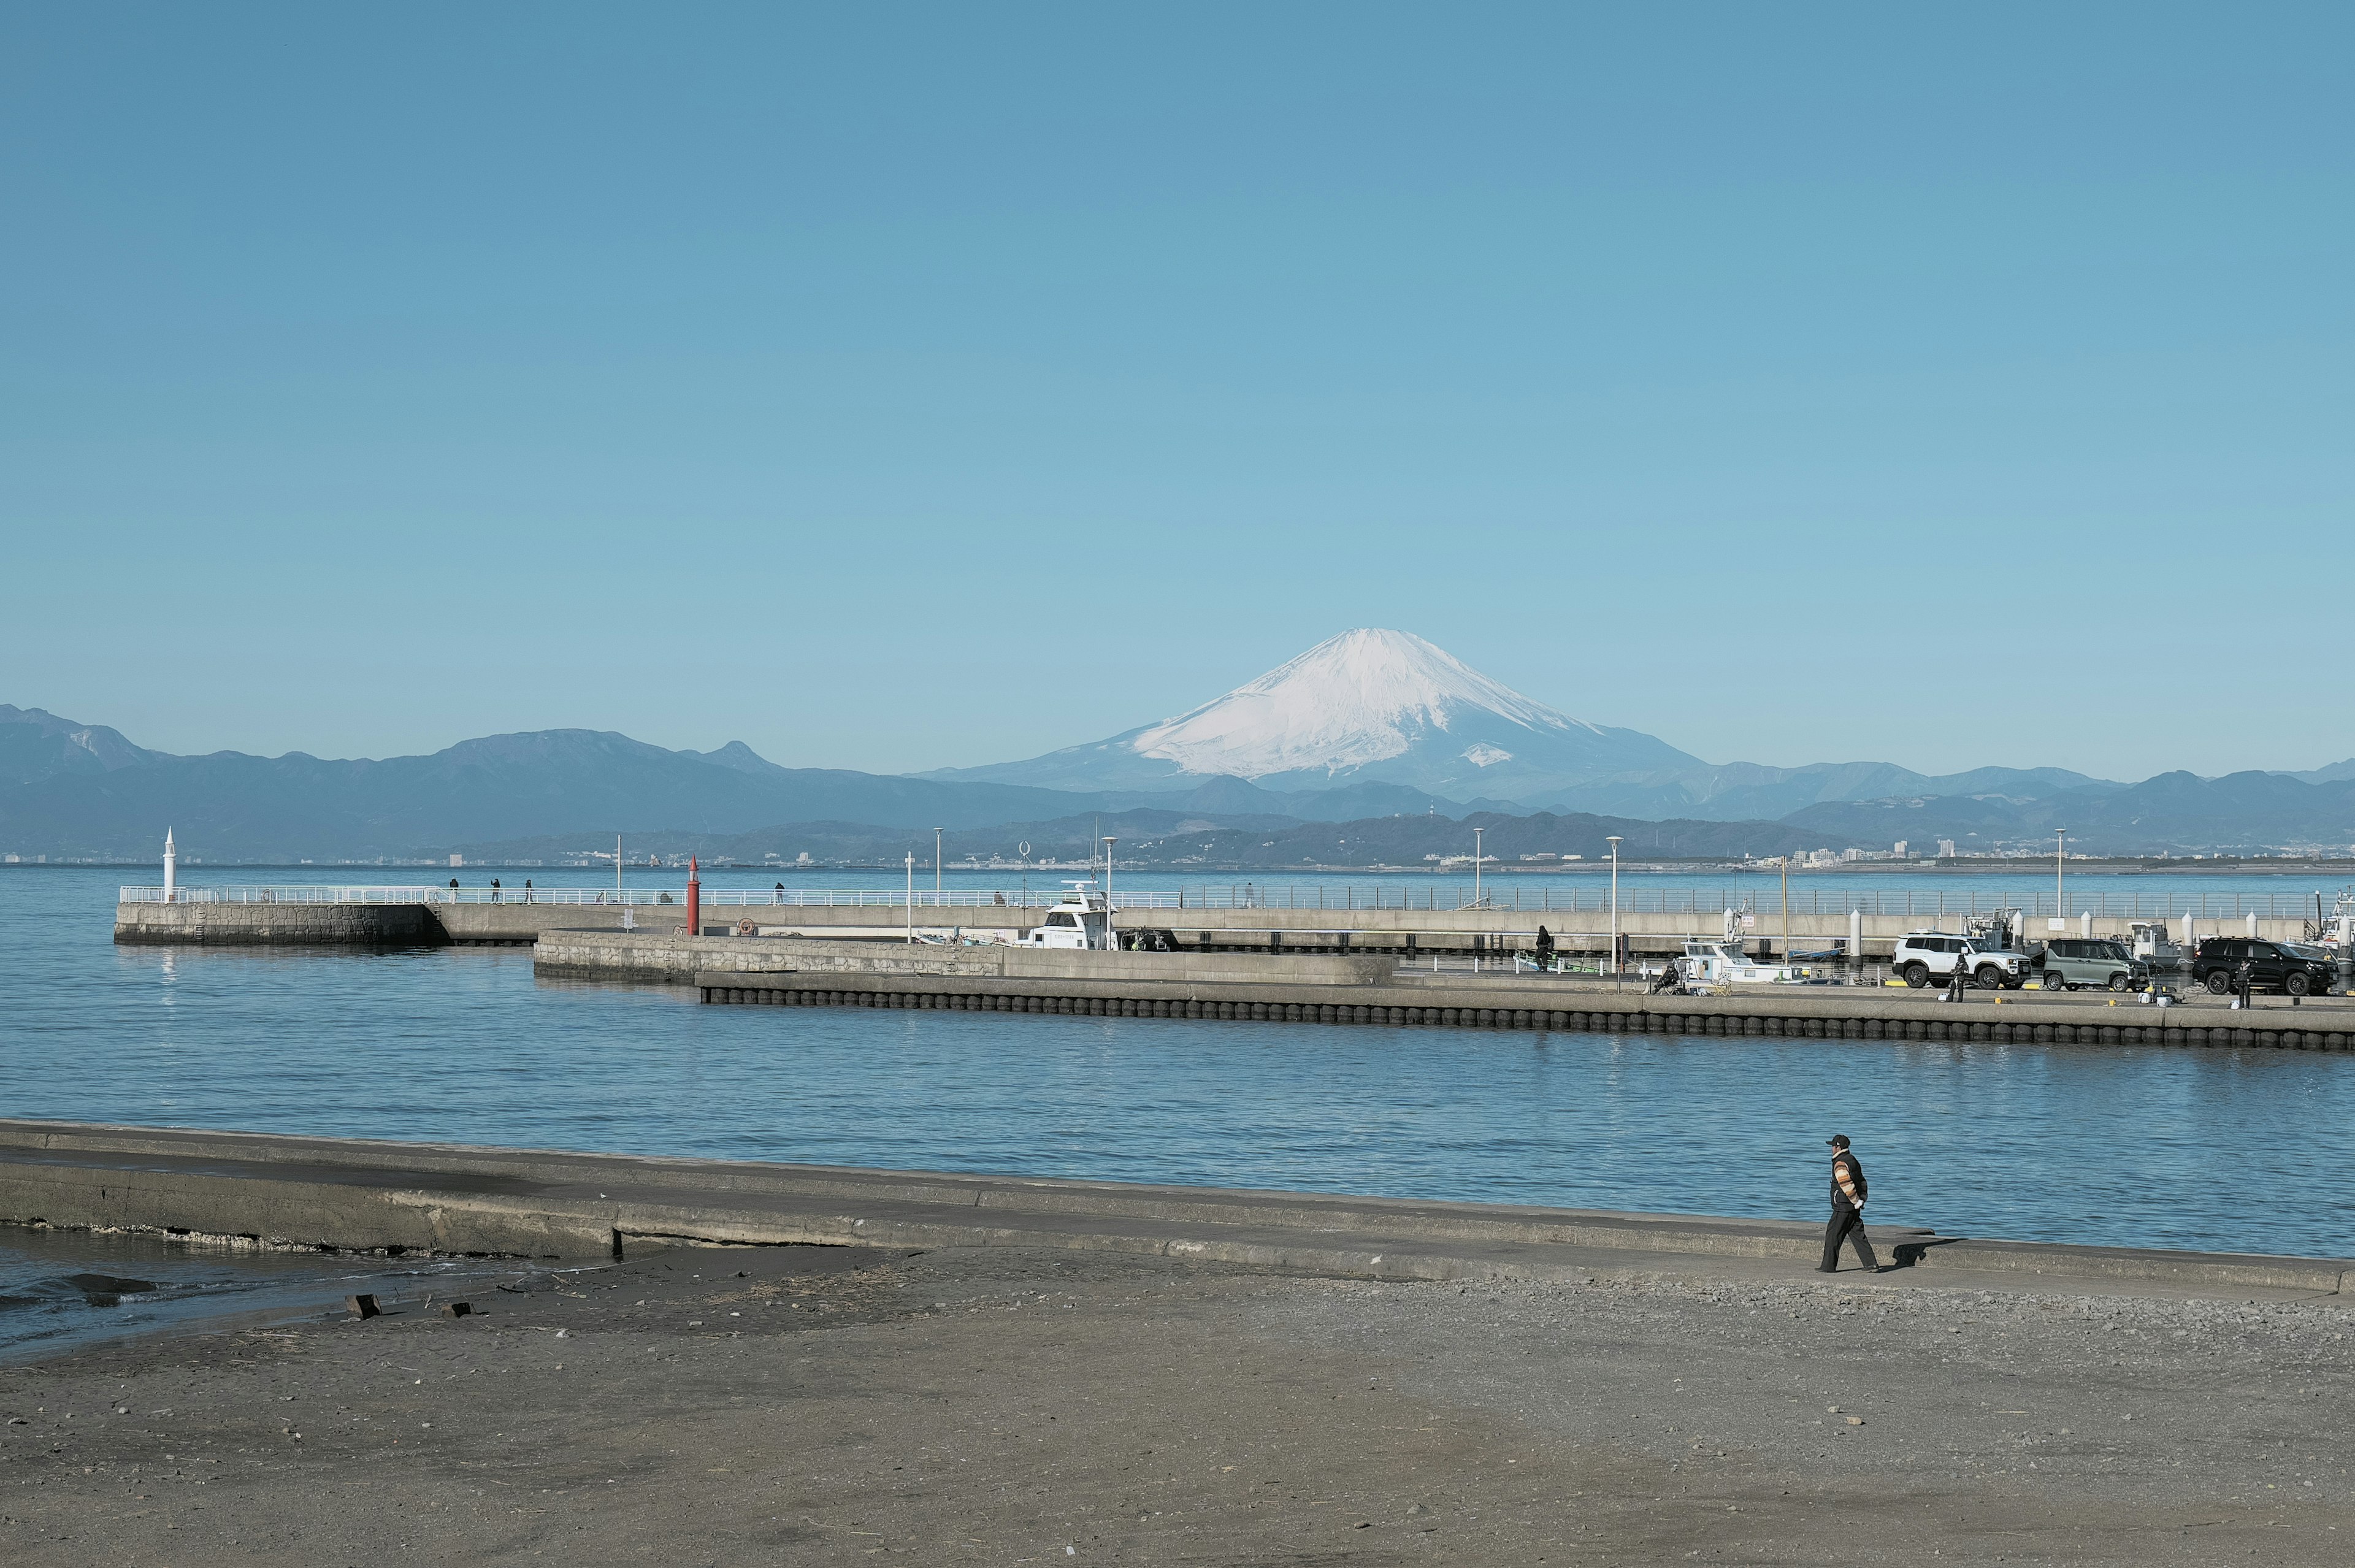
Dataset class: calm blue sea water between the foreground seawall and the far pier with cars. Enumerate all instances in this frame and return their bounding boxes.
[0,869,2355,1255]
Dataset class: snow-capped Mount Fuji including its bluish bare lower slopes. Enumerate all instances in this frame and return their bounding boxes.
[925,629,1702,800]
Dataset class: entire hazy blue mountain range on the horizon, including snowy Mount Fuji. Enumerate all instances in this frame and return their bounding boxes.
[0,629,2355,869]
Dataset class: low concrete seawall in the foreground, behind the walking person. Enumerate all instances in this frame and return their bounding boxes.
[0,1121,2355,1293]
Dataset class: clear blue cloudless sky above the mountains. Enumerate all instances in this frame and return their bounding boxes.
[0,2,2355,777]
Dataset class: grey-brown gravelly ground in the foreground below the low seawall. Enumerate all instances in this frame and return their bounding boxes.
[0,1248,2355,1566]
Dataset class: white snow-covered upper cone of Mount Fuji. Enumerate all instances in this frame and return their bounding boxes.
[1130,626,1601,779]
